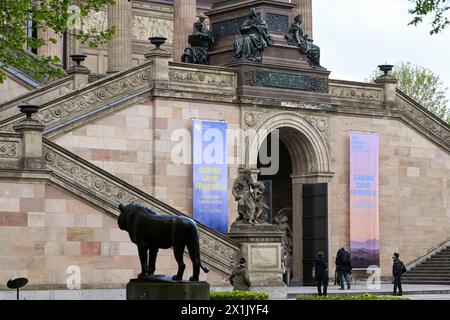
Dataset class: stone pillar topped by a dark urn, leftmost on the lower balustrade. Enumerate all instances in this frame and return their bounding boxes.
[13,105,45,169]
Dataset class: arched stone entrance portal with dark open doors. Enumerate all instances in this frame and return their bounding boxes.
[247,113,333,285]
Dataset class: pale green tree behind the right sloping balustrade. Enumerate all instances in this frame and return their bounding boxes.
[370,62,450,125]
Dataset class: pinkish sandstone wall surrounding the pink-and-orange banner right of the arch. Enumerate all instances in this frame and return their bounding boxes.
[330,116,450,276]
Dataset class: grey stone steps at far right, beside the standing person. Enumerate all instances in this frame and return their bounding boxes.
[402,246,450,285]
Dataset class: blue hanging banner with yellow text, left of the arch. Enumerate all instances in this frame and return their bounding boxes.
[192,120,228,233]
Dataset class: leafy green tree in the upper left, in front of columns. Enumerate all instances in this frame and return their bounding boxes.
[0,0,115,83]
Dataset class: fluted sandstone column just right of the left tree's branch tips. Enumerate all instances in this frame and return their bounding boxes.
[107,0,132,73]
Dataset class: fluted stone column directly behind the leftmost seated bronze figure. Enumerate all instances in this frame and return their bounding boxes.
[173,0,197,62]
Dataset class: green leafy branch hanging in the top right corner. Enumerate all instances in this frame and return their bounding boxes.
[409,0,450,34]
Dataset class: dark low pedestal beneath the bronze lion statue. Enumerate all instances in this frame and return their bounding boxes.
[127,276,210,300]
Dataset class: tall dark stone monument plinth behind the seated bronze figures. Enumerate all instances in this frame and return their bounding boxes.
[206,0,331,106]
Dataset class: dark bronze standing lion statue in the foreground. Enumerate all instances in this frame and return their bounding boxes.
[118,204,209,281]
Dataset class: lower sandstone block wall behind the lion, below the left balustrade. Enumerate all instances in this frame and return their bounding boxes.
[0,181,223,289]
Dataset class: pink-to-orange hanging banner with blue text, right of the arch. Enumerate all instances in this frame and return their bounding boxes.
[350,132,380,268]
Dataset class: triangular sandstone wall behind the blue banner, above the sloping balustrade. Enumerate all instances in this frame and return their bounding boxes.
[54,99,240,230]
